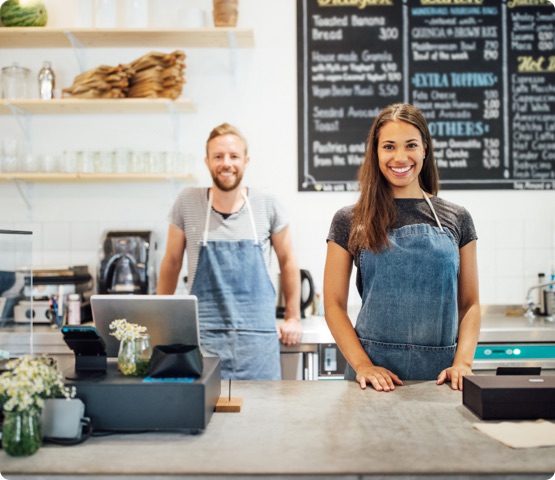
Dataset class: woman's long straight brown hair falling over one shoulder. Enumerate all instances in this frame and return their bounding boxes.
[349,103,439,255]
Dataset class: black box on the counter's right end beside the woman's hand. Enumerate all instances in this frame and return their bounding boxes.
[463,375,555,420]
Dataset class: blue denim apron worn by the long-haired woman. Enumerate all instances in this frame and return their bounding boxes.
[345,192,460,380]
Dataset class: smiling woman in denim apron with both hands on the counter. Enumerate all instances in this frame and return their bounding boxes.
[324,104,480,392]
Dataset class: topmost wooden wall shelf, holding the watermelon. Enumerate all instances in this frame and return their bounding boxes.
[0,27,254,48]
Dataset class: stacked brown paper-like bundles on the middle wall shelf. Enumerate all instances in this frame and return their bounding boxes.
[63,50,185,100]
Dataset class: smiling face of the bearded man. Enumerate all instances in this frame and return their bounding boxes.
[205,134,249,192]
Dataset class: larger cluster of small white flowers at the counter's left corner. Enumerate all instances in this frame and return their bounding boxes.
[0,356,75,413]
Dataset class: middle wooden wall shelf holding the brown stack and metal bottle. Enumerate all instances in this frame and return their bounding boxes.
[0,98,196,115]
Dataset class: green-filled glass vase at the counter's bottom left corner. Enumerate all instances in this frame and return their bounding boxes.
[2,410,42,457]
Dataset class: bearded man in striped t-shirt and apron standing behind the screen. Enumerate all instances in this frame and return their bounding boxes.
[157,123,302,380]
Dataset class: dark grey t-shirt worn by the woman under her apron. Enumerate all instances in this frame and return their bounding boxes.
[327,196,478,293]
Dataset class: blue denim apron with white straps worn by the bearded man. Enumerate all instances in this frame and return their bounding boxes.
[191,189,281,380]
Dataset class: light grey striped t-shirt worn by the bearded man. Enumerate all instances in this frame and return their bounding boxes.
[168,188,288,290]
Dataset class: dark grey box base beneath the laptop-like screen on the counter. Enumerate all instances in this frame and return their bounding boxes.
[66,357,221,433]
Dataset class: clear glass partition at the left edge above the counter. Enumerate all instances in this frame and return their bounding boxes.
[0,230,34,358]
